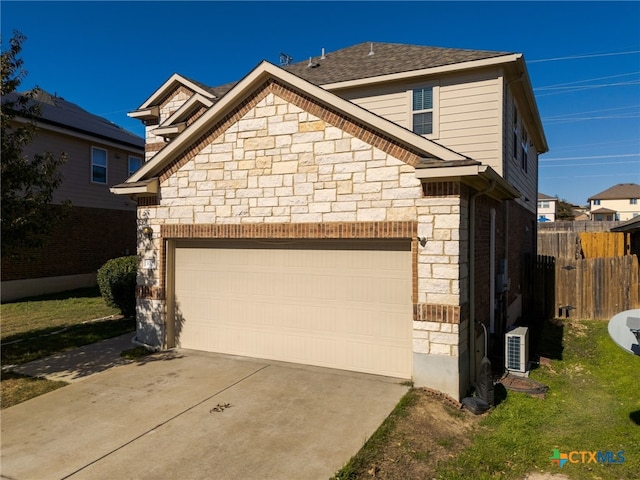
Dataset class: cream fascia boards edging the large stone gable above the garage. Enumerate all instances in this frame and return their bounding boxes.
[129,61,467,182]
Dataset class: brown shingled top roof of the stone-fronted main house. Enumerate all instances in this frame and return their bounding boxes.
[283,42,512,85]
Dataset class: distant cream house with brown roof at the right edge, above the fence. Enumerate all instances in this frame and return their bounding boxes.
[589,183,640,221]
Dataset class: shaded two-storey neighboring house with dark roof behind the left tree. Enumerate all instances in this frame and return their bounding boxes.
[2,91,144,301]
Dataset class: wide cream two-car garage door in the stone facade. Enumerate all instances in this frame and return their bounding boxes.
[175,240,412,378]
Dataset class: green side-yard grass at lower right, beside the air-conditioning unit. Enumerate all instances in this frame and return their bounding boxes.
[437,321,640,480]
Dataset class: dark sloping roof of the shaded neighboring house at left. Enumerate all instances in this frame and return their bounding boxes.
[2,90,144,149]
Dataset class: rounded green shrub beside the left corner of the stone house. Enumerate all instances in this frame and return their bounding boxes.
[98,255,138,317]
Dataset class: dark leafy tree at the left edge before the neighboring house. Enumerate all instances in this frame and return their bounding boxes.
[0,32,69,258]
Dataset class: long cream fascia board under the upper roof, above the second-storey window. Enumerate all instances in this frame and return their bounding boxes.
[322,53,522,90]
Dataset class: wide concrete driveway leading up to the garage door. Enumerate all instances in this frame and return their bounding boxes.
[1,350,407,480]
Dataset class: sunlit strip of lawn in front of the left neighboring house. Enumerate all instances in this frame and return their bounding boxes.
[0,287,119,343]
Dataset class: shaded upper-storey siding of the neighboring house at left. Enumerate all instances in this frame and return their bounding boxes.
[24,129,144,210]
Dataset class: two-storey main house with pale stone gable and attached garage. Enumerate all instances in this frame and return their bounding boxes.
[112,43,548,398]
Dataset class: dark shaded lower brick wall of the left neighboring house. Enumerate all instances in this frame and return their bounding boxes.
[2,207,136,281]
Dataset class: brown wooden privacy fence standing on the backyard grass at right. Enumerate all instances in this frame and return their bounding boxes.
[536,255,640,320]
